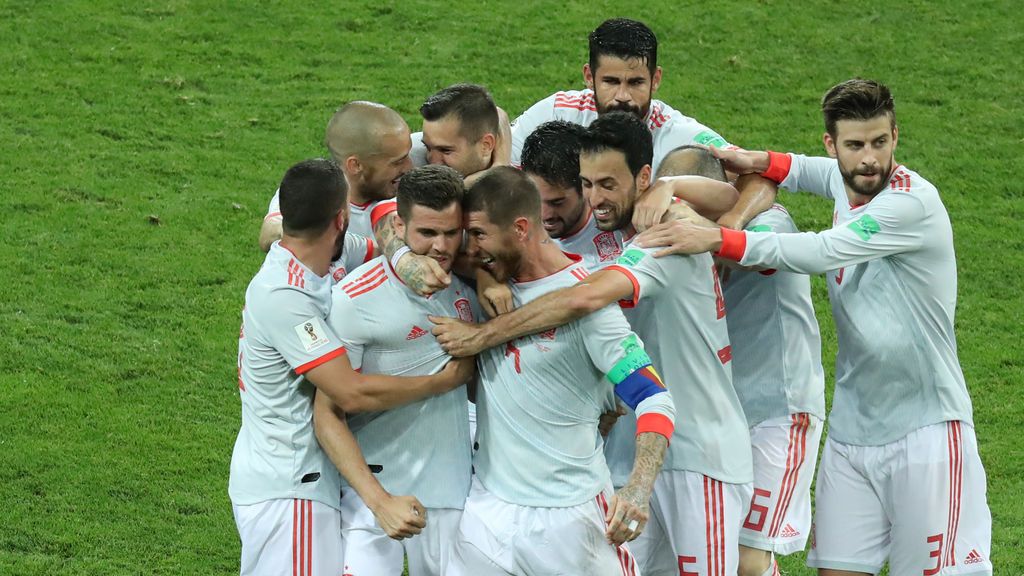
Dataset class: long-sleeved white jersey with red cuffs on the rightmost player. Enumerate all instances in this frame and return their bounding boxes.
[720,153,973,446]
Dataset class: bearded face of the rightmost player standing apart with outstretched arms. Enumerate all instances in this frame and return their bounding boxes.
[823,114,899,198]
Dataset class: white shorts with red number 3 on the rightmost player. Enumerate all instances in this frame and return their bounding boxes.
[807,421,992,576]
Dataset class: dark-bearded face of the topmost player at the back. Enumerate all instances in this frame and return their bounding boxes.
[583,56,662,119]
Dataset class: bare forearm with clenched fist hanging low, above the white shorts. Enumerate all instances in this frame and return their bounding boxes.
[313,393,427,540]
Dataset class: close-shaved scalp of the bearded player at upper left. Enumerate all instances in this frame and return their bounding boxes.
[324,100,409,165]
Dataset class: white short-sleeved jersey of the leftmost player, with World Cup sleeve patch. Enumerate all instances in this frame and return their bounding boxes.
[227,242,345,508]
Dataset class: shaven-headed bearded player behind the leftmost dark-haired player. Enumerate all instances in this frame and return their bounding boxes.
[260,100,413,247]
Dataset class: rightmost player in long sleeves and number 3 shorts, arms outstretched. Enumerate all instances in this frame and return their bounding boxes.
[643,79,992,576]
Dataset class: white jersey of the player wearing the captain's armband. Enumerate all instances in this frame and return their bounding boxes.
[473,255,675,507]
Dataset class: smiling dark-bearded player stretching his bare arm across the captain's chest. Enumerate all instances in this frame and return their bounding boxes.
[434,112,753,574]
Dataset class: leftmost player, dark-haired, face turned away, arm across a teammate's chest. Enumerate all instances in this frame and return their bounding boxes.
[228,160,473,576]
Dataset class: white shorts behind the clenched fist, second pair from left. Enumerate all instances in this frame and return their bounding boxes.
[335,491,462,576]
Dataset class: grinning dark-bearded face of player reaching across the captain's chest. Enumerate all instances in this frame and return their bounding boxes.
[580,150,650,231]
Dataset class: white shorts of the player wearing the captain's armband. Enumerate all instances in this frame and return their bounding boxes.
[450,477,639,576]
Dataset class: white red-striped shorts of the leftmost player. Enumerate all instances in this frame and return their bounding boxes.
[231,499,344,576]
